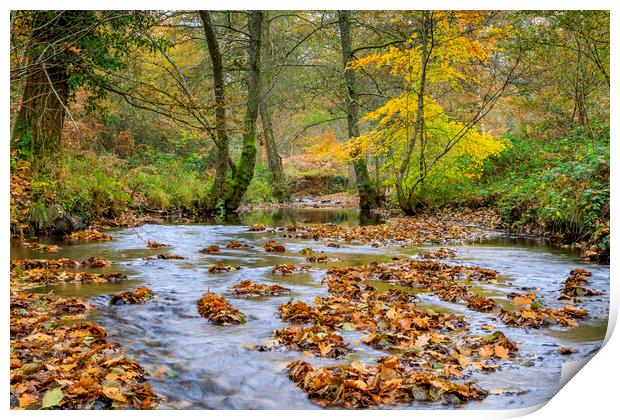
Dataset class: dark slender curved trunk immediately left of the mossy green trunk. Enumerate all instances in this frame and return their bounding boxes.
[198,10,229,213]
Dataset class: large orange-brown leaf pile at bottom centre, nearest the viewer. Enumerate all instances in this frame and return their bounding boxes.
[288,356,487,408]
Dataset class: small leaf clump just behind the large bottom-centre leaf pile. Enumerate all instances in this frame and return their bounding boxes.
[257,325,350,358]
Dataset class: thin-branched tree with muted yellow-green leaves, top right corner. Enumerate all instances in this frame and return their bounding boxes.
[509,10,610,137]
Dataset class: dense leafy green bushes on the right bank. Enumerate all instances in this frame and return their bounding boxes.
[480,129,609,249]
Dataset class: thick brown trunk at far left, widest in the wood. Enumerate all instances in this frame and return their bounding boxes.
[12,12,69,156]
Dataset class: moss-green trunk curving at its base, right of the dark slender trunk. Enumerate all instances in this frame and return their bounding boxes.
[224,10,263,212]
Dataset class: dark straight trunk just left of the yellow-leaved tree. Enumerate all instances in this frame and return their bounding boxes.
[338,10,379,210]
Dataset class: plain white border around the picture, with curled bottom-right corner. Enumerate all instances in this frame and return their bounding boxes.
[0,0,620,420]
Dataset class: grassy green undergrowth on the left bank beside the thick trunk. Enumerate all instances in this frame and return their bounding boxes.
[26,150,210,220]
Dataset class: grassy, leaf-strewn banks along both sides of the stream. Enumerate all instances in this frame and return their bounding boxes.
[10,145,609,262]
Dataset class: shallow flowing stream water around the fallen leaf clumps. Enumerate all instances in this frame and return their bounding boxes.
[11,209,609,409]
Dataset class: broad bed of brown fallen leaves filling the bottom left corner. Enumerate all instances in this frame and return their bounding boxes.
[10,292,160,409]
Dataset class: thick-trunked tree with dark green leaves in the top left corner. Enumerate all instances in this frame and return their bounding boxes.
[11,10,160,156]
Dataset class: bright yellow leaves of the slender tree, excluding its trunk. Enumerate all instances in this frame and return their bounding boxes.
[345,11,509,194]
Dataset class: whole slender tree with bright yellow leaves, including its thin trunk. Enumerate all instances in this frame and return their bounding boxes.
[349,11,514,214]
